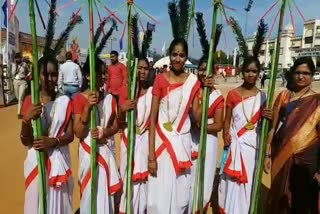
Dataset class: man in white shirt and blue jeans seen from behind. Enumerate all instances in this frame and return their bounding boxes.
[58,52,83,97]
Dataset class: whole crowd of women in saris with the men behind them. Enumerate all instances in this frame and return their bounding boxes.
[15,39,320,214]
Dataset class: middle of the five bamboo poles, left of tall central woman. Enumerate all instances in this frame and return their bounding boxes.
[126,0,137,214]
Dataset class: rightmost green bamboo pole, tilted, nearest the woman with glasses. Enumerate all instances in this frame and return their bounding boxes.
[250,0,287,214]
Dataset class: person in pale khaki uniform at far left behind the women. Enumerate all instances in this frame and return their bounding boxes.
[11,52,29,119]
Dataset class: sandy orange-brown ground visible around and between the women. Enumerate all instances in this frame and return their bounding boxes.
[0,78,320,213]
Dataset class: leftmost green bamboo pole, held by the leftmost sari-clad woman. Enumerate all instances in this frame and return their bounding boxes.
[29,0,47,214]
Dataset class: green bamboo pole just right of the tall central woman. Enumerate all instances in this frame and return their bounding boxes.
[192,0,221,214]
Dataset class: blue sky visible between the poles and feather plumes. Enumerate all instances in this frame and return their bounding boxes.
[17,0,320,58]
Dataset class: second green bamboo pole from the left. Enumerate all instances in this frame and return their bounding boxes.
[88,0,97,214]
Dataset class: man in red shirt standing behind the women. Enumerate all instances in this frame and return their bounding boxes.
[105,51,127,101]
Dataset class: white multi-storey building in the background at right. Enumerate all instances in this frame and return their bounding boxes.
[247,19,320,69]
